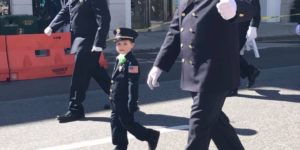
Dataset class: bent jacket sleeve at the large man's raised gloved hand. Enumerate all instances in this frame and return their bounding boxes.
[229,0,255,23]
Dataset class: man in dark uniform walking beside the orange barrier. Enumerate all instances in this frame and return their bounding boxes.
[44,0,111,122]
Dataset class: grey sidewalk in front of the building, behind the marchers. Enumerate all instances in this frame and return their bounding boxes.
[106,22,300,53]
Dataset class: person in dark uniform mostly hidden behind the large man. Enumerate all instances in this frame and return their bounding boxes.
[229,0,261,96]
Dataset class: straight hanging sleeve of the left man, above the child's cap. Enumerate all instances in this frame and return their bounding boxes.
[91,0,111,49]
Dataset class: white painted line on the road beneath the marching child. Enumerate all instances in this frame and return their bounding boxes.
[38,125,189,150]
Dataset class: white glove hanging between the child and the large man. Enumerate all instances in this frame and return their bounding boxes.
[147,66,162,90]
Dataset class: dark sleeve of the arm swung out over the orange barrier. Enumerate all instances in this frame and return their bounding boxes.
[49,2,70,32]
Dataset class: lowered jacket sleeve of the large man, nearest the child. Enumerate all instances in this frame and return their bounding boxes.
[154,9,180,71]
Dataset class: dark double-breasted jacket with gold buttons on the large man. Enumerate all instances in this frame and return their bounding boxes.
[154,0,253,92]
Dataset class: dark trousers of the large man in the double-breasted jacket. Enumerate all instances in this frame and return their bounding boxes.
[186,91,244,150]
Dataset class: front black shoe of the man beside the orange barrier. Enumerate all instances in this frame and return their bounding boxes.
[56,111,84,123]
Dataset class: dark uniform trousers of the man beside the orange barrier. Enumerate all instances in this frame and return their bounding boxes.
[69,51,110,111]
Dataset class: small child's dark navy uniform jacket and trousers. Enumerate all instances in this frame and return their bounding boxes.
[109,52,151,150]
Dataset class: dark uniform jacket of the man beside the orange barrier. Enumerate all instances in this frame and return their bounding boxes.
[50,0,111,53]
